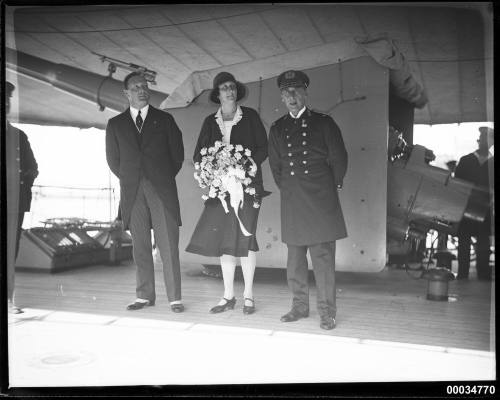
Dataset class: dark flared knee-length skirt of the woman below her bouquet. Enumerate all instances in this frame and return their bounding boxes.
[186,193,260,257]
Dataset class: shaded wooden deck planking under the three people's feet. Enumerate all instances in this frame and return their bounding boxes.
[16,263,494,351]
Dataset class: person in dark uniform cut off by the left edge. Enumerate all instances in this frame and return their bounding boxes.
[5,82,38,314]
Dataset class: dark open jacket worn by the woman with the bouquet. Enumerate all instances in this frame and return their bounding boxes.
[193,106,268,201]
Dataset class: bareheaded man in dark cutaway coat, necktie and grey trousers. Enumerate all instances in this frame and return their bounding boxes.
[106,72,184,312]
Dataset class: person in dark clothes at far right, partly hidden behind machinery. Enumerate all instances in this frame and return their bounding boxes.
[455,126,494,281]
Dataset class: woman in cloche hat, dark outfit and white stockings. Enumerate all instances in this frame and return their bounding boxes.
[186,72,267,314]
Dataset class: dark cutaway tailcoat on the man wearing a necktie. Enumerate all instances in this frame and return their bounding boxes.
[106,105,184,229]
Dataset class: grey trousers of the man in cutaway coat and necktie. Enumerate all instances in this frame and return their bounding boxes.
[130,178,181,302]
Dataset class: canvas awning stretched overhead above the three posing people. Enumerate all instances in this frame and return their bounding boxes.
[5,3,492,127]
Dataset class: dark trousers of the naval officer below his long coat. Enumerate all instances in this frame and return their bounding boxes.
[287,242,337,318]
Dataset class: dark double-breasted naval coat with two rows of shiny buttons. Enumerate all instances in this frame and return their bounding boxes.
[269,109,347,246]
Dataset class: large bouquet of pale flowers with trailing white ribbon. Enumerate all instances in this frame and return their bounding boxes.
[194,141,260,236]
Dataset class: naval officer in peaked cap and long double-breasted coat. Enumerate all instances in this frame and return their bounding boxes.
[269,71,347,329]
